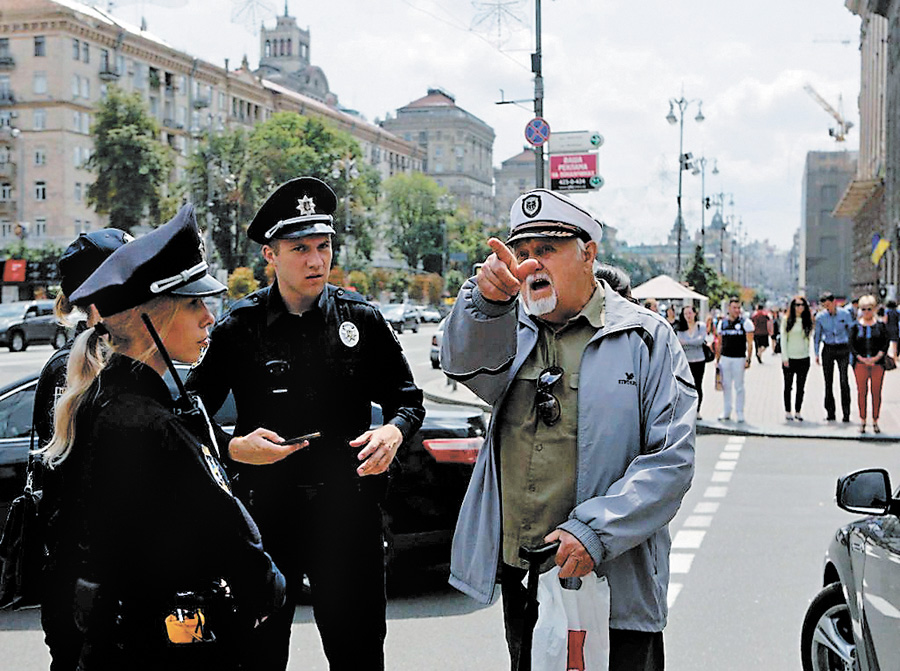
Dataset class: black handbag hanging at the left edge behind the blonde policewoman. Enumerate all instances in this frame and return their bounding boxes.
[0,438,44,609]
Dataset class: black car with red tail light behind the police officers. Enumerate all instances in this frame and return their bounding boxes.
[0,365,485,564]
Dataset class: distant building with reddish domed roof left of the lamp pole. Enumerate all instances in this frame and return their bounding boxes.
[381,88,494,223]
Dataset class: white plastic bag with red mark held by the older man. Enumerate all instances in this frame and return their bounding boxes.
[531,566,609,671]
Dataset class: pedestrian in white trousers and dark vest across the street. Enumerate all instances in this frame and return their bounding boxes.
[716,298,753,423]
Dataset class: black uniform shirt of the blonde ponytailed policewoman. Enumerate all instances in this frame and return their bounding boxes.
[44,355,284,624]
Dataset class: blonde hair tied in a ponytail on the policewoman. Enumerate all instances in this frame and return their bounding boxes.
[37,296,183,468]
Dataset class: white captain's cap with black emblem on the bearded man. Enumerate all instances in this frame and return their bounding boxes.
[506,189,603,245]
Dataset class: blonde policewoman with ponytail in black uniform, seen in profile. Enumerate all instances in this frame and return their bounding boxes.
[43,205,284,671]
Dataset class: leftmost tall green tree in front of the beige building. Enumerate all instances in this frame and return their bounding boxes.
[86,86,173,231]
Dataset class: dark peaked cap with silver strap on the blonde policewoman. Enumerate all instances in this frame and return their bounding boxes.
[69,204,225,317]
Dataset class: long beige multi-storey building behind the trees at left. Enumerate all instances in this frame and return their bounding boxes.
[0,0,422,246]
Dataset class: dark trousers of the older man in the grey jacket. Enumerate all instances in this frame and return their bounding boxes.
[500,563,665,671]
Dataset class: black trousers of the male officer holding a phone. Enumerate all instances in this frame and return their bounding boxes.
[245,488,387,671]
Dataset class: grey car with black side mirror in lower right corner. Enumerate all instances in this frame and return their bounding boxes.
[800,468,900,671]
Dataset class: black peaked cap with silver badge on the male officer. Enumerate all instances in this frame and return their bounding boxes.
[247,177,337,245]
